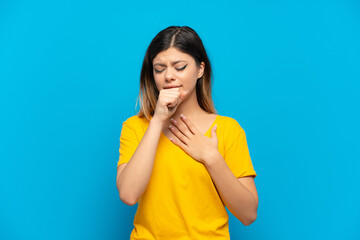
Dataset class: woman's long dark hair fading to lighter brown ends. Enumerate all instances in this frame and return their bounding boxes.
[136,26,216,120]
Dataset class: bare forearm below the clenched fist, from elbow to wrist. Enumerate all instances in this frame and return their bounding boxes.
[117,121,162,204]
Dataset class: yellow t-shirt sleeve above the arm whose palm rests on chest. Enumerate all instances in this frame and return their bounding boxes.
[225,125,257,178]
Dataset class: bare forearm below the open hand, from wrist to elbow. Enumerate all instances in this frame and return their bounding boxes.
[205,152,257,225]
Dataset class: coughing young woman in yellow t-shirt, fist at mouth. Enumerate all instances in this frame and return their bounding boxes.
[116,26,258,240]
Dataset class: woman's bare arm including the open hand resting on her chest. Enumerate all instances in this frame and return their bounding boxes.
[170,115,258,225]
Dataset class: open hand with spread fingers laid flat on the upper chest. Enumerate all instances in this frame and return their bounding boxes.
[169,114,218,164]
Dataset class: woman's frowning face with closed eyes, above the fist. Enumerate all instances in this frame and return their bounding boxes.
[153,47,205,95]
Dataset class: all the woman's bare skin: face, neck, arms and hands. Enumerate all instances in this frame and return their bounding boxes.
[116,47,258,225]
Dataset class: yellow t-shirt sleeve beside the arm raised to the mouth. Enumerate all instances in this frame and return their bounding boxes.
[117,121,139,167]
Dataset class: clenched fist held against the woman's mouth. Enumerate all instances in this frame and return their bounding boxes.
[153,87,188,123]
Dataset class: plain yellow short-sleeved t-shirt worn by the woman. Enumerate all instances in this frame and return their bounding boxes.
[117,115,256,240]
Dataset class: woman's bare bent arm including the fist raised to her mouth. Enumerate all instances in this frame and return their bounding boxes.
[116,87,187,205]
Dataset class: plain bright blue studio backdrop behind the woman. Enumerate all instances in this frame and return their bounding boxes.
[0,0,360,240]
